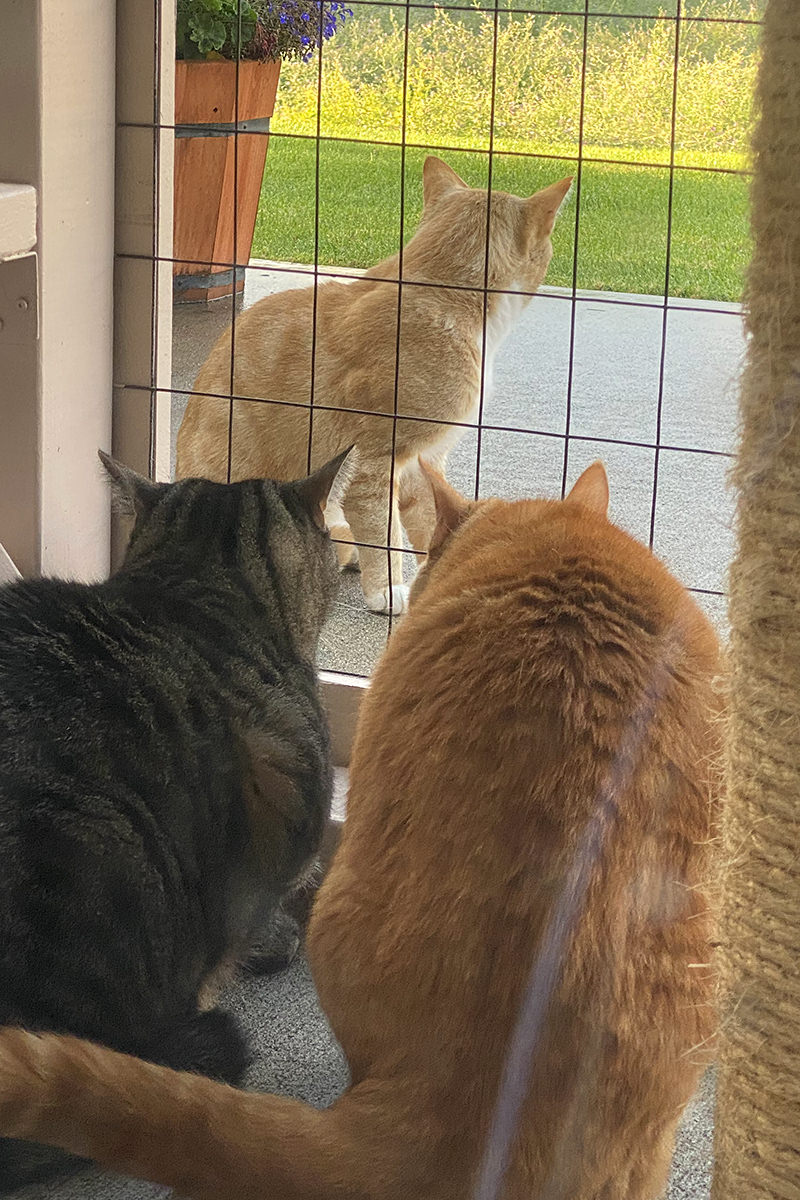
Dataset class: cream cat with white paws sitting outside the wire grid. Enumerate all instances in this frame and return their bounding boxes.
[176,156,571,613]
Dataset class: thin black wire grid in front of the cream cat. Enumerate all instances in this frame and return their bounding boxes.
[119,0,760,674]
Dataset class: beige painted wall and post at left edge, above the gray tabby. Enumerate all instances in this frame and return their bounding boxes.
[0,0,116,578]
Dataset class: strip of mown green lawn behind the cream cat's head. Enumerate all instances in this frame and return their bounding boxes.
[253,137,750,300]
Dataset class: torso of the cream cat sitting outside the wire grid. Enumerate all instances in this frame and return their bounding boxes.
[176,259,480,479]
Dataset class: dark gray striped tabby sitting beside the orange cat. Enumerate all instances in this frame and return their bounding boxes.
[0,451,347,1192]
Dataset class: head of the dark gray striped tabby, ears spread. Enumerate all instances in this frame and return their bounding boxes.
[100,446,353,654]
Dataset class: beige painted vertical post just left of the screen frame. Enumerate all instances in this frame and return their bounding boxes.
[38,0,115,577]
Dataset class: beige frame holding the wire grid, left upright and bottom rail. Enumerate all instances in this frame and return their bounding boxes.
[115,0,367,766]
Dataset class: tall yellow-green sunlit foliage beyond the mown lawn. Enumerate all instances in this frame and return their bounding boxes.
[275,0,759,162]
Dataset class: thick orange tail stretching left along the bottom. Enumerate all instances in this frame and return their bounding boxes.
[0,1028,376,1200]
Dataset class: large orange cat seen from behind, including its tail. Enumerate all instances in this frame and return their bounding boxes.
[0,463,720,1200]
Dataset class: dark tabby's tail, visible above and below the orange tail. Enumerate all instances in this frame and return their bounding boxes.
[0,1008,249,1195]
